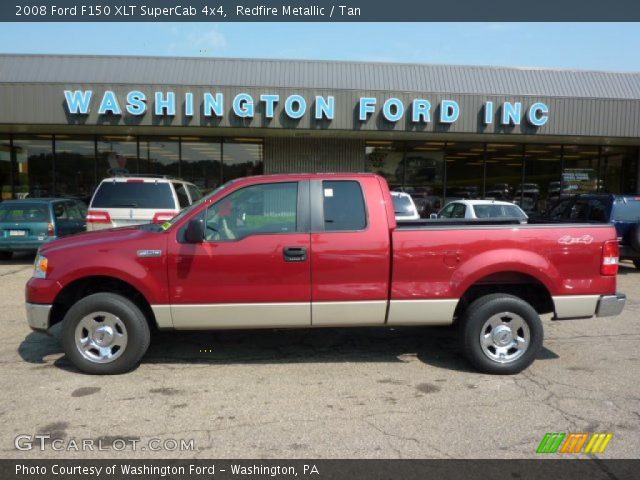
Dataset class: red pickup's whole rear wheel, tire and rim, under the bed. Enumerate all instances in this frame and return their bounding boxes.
[461,293,544,375]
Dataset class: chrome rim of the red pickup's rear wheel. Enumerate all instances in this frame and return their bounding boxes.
[480,312,531,363]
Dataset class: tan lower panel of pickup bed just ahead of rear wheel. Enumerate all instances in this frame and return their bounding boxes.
[387,299,458,325]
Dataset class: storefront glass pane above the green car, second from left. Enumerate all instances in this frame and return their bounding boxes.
[13,135,55,198]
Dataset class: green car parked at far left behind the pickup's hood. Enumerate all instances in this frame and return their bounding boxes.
[0,198,87,260]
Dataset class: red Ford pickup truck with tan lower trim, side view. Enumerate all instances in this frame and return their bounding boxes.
[26,174,625,374]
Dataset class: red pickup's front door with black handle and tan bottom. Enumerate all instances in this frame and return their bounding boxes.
[168,181,311,329]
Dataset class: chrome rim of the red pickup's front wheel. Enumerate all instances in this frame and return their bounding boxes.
[75,312,128,363]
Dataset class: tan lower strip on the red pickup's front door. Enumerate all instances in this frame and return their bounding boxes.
[171,303,311,330]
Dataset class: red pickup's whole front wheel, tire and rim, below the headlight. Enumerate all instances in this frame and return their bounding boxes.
[62,293,150,375]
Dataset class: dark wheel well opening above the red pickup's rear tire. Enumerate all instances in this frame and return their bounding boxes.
[454,271,554,318]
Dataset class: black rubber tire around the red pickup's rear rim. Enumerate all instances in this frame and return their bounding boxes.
[460,293,544,375]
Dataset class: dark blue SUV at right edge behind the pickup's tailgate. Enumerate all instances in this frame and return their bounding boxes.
[529,193,640,269]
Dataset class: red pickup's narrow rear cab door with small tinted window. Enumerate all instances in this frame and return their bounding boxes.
[311,177,391,326]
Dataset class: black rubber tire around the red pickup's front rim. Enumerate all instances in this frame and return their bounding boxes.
[62,293,151,375]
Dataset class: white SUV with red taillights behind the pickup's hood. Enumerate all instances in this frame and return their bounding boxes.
[87,175,202,231]
